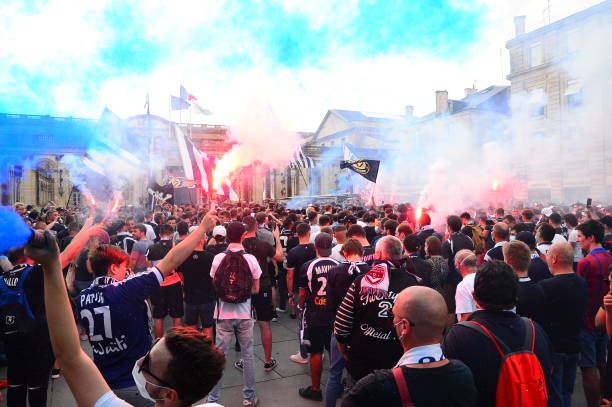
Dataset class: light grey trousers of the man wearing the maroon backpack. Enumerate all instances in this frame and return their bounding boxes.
[208,319,255,403]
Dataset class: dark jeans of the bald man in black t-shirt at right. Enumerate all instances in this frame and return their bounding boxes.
[549,353,578,407]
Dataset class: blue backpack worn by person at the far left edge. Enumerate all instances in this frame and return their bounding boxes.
[0,266,36,335]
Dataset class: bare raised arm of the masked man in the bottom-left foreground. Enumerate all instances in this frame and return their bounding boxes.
[26,231,110,407]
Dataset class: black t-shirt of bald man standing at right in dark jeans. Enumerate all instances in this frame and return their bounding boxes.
[539,273,588,354]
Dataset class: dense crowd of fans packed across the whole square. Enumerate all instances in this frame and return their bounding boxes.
[0,202,612,407]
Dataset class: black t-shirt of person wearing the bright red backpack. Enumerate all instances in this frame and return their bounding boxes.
[442,310,552,407]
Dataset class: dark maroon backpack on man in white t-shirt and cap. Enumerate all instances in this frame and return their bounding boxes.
[213,250,253,304]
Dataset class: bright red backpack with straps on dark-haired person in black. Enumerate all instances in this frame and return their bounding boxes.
[459,318,548,407]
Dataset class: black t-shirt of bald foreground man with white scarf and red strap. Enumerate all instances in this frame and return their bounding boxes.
[342,359,477,407]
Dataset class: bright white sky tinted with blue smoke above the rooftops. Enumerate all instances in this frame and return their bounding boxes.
[0,0,599,131]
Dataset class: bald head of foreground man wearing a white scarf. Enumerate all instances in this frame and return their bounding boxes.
[393,286,448,347]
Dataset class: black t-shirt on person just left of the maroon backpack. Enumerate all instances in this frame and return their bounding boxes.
[176,250,215,304]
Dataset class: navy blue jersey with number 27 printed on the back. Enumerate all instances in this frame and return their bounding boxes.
[77,267,163,389]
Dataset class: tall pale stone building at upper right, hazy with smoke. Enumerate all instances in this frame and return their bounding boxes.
[506,0,612,203]
